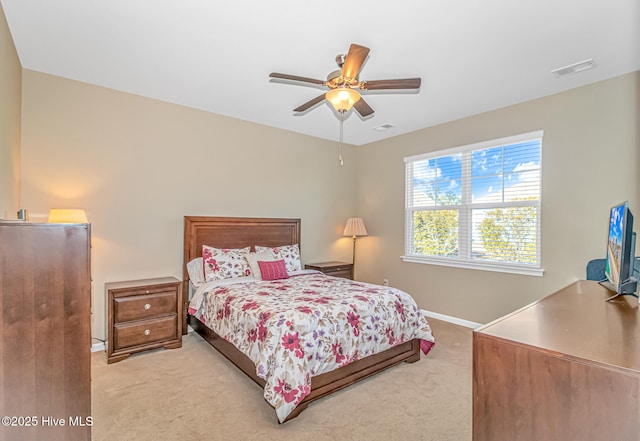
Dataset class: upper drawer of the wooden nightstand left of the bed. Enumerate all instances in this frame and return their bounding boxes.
[113,290,178,323]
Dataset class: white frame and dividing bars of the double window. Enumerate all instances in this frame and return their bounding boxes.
[401,130,544,276]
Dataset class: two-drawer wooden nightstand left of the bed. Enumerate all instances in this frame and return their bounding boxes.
[104,277,182,363]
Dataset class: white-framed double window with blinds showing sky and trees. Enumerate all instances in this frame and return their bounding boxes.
[403,131,543,275]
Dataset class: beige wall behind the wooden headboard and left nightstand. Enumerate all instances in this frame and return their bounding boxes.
[22,70,355,339]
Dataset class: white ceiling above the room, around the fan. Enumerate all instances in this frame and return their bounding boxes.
[0,0,640,145]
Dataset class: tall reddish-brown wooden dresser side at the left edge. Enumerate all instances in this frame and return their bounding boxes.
[0,223,93,441]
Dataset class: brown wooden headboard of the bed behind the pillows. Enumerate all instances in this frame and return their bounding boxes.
[182,216,300,334]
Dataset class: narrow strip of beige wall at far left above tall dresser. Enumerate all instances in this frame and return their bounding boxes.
[0,3,22,219]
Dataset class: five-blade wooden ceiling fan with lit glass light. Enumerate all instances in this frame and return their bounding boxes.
[269,44,421,116]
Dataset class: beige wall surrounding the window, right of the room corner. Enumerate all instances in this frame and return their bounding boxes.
[357,72,640,323]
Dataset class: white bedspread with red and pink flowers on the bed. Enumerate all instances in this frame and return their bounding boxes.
[189,271,434,422]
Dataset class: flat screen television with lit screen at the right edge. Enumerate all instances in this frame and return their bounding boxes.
[604,202,638,300]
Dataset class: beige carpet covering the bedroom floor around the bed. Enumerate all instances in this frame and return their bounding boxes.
[92,319,472,441]
